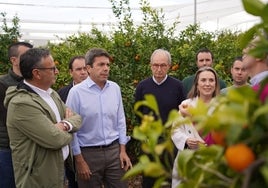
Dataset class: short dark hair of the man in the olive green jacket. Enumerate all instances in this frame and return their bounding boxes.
[20,48,50,80]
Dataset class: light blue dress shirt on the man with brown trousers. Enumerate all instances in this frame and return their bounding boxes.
[66,77,129,155]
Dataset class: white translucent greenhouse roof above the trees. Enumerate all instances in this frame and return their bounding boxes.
[0,0,268,45]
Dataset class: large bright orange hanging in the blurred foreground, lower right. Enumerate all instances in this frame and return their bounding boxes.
[224,143,255,172]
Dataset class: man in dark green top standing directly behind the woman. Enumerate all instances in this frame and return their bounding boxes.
[182,48,226,95]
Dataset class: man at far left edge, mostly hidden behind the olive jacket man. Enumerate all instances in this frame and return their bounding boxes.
[0,42,33,188]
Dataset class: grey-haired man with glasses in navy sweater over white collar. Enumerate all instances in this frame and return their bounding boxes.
[135,49,185,188]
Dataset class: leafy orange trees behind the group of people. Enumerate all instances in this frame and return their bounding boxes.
[0,0,242,162]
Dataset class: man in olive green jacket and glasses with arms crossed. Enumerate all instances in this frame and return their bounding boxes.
[4,48,81,188]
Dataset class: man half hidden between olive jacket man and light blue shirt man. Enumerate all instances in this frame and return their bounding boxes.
[58,56,88,188]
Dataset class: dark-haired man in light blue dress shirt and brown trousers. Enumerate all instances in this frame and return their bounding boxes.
[66,48,132,188]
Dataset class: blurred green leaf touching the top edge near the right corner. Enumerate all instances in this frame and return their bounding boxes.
[242,0,265,16]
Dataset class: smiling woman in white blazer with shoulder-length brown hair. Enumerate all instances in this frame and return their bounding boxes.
[171,67,220,188]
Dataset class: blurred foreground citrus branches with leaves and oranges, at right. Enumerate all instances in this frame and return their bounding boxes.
[125,0,268,188]
